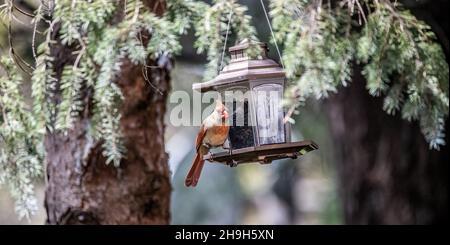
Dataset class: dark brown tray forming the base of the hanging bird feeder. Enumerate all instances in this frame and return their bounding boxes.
[203,140,319,167]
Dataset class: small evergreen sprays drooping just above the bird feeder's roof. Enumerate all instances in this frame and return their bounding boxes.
[169,0,258,81]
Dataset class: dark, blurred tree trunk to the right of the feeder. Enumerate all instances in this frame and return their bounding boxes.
[325,67,450,224]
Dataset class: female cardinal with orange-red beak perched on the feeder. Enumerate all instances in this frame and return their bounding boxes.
[184,100,230,187]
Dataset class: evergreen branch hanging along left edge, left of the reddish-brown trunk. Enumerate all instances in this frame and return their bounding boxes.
[0,56,44,218]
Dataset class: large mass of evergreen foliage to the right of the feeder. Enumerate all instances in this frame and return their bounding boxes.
[271,0,449,149]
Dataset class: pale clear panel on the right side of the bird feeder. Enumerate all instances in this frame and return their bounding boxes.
[254,84,285,145]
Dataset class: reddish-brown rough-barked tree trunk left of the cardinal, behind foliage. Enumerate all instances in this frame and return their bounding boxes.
[45,1,171,224]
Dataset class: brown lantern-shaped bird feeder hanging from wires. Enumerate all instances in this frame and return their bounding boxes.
[192,40,318,166]
